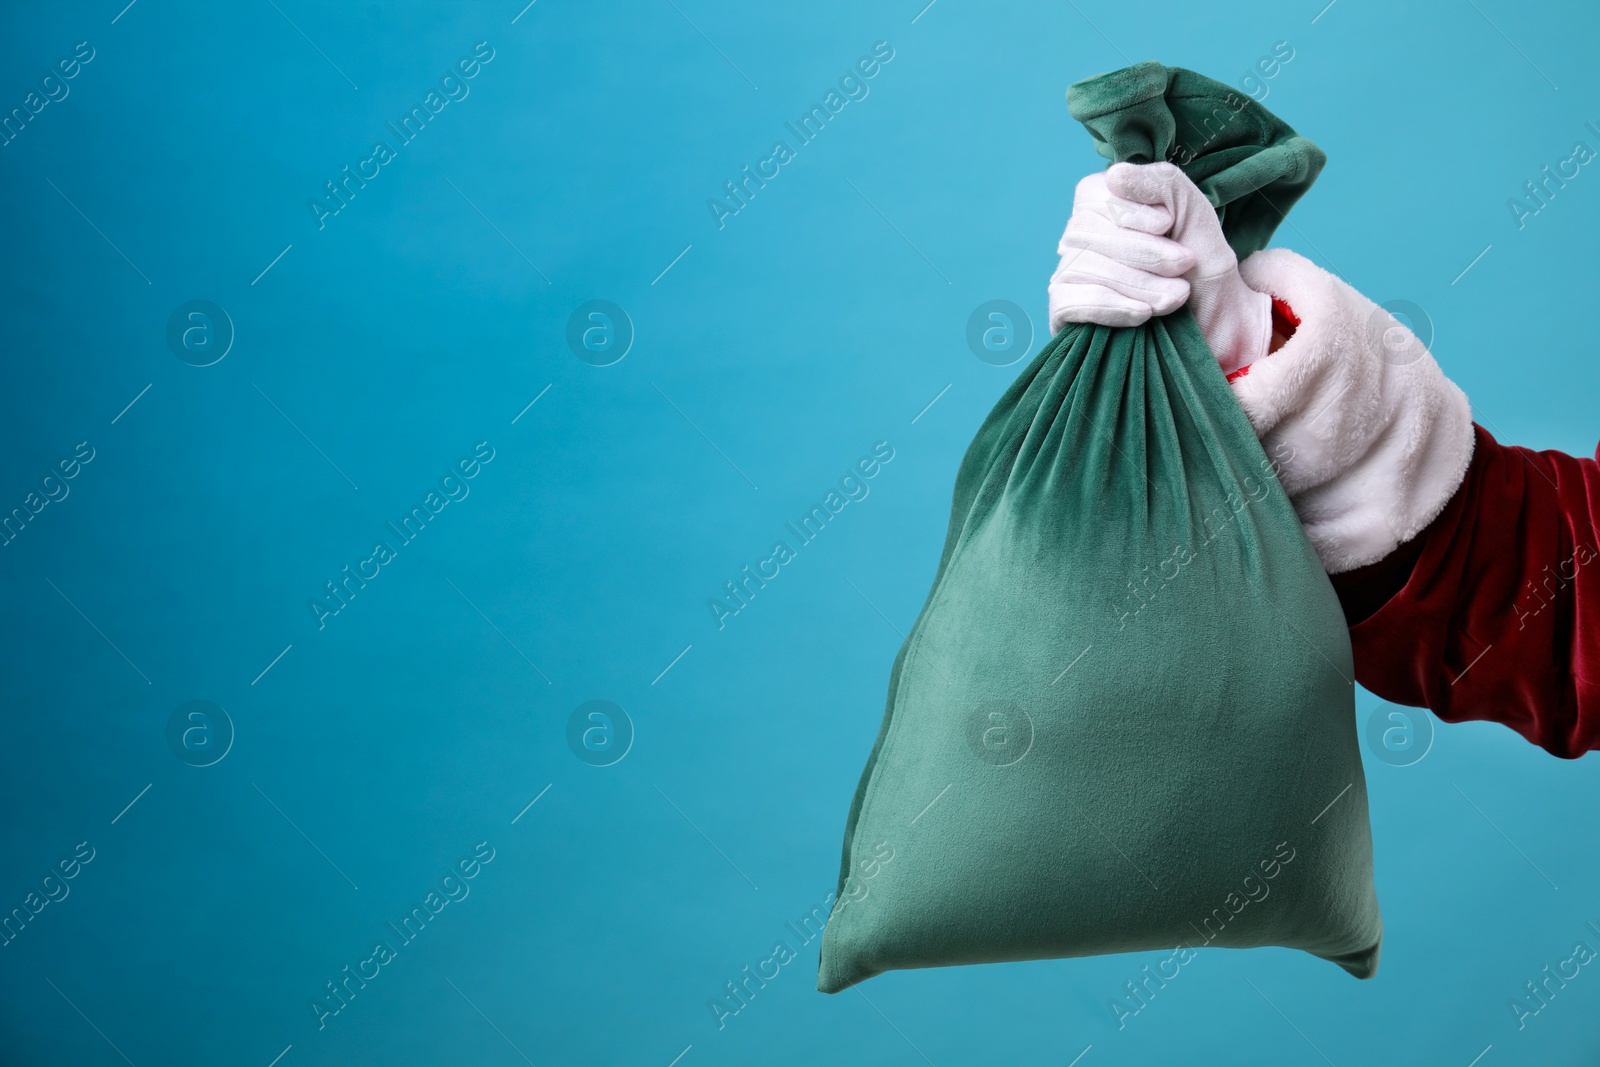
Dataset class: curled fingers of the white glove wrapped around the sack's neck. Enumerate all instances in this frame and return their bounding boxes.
[1050,171,1195,334]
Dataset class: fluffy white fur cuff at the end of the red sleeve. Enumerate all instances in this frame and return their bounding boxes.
[1232,248,1472,574]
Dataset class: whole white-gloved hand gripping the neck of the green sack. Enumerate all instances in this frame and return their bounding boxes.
[1050,163,1272,373]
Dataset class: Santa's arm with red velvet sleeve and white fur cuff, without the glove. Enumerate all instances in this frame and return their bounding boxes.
[1230,250,1600,757]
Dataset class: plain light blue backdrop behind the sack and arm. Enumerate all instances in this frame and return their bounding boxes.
[0,0,1600,1067]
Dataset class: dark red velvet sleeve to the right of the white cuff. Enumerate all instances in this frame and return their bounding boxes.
[1333,426,1600,758]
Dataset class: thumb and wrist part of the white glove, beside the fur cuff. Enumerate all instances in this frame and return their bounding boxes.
[1100,163,1272,373]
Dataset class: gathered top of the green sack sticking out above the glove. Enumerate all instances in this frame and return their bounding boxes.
[1067,61,1328,259]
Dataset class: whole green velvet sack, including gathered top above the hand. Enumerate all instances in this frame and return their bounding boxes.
[818,62,1382,992]
